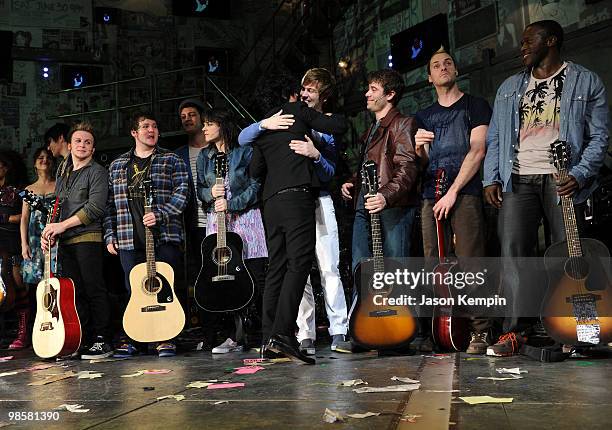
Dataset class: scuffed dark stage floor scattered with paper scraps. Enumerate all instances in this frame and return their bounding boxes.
[0,346,612,430]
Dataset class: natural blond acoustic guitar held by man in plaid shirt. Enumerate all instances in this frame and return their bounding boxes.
[123,180,185,342]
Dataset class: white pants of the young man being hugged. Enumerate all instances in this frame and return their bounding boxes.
[297,195,348,342]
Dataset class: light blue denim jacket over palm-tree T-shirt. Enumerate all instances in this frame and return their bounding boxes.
[483,61,608,203]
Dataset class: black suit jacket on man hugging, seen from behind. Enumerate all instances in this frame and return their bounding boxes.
[250,102,347,200]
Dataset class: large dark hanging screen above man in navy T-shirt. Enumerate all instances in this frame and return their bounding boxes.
[389,13,450,73]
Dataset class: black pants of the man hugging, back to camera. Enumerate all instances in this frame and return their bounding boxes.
[262,191,315,342]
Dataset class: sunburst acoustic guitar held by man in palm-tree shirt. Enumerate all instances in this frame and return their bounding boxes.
[540,141,612,346]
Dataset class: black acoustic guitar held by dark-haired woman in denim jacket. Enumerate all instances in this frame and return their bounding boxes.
[195,152,255,312]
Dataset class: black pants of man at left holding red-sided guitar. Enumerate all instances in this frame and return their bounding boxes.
[59,242,110,344]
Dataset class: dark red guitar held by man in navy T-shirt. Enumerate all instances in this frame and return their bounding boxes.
[431,169,470,351]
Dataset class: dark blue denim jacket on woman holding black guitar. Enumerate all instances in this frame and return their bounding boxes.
[197,145,260,212]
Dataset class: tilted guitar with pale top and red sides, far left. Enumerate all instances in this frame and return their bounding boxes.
[30,197,81,358]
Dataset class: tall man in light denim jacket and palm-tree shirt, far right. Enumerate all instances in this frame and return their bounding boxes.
[483,20,608,356]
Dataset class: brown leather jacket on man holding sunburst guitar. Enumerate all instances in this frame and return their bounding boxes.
[352,107,419,208]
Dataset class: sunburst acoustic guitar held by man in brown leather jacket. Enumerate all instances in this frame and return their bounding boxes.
[349,160,416,350]
